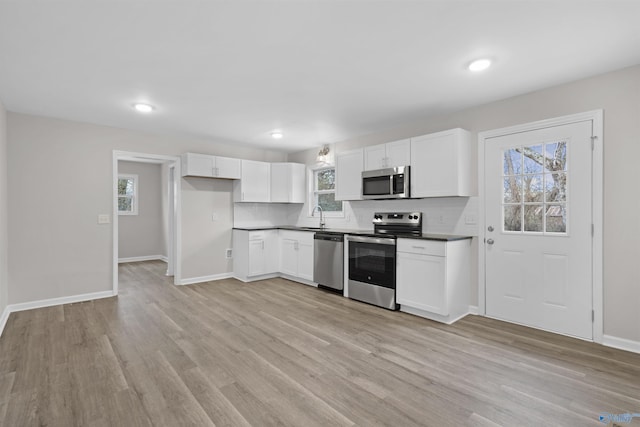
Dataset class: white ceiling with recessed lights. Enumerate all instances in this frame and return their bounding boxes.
[0,0,640,152]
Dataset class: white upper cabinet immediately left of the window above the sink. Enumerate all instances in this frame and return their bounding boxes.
[271,163,307,203]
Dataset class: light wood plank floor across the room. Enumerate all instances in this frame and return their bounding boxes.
[0,262,640,427]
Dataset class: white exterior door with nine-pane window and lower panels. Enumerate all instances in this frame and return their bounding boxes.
[484,120,593,339]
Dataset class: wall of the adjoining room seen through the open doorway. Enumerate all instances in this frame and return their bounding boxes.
[118,161,167,259]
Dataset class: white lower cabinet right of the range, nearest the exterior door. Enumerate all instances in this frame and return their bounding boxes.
[396,239,471,323]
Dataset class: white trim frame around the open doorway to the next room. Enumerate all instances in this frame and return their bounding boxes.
[112,150,182,295]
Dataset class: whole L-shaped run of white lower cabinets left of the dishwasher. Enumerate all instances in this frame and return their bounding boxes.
[233,229,314,284]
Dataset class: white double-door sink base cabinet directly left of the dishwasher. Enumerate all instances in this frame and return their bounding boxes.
[280,230,314,282]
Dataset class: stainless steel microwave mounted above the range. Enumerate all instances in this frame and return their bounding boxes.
[362,166,411,199]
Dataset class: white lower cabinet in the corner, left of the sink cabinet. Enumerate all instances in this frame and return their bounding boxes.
[233,230,278,282]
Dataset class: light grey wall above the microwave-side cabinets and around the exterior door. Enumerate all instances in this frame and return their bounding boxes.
[288,66,640,342]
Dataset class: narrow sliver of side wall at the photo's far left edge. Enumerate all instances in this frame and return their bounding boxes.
[0,102,9,316]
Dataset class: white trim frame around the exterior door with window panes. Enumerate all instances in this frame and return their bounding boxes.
[478,110,604,344]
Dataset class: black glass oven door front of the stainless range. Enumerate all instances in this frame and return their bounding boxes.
[349,242,396,289]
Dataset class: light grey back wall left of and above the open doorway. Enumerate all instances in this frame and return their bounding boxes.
[7,113,286,304]
